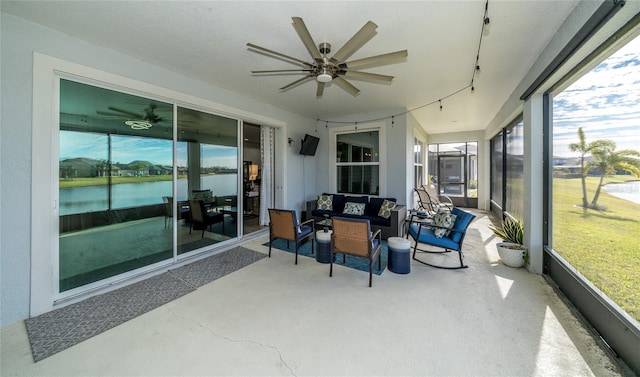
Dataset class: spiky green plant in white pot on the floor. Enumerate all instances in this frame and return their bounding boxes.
[489,217,529,267]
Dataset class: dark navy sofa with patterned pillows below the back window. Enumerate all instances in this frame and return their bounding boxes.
[307,193,407,240]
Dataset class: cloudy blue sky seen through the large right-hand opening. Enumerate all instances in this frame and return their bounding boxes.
[553,36,640,157]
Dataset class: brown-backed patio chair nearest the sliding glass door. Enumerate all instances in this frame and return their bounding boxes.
[269,208,315,264]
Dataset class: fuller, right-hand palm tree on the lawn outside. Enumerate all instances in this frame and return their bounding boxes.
[586,140,640,208]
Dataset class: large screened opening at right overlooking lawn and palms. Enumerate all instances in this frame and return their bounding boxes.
[549,33,640,321]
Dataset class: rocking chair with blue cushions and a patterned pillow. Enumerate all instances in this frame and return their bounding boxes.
[407,207,476,270]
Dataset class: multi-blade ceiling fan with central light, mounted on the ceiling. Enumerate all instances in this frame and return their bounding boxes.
[247,17,408,97]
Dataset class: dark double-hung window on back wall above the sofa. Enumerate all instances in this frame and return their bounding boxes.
[336,130,380,195]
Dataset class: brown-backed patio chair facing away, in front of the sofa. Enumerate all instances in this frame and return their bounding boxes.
[329,216,382,286]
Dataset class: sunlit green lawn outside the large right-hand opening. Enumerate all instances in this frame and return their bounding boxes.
[553,176,640,321]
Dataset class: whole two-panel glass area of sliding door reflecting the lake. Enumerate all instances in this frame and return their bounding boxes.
[57,79,242,292]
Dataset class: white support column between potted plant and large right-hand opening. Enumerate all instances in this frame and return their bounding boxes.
[523,94,544,274]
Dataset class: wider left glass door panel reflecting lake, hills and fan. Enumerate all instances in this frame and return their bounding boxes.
[58,79,173,292]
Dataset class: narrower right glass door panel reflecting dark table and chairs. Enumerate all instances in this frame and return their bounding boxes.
[176,107,242,254]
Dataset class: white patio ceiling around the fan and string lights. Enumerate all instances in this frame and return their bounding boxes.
[2,0,577,134]
